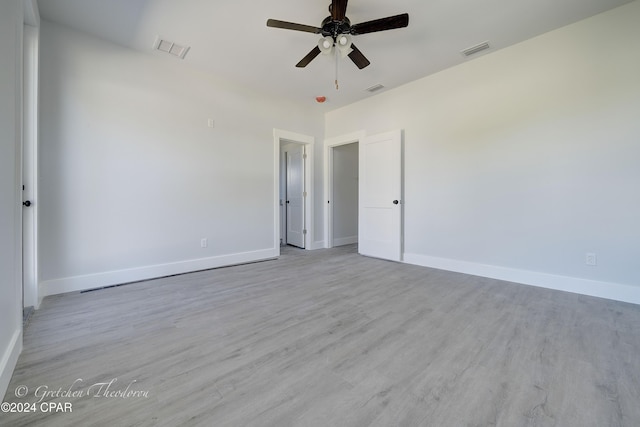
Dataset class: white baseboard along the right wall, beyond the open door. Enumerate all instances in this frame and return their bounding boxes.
[404,253,640,304]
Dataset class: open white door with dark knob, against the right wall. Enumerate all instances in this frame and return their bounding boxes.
[358,130,402,261]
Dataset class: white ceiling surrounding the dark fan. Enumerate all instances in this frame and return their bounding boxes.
[38,0,631,109]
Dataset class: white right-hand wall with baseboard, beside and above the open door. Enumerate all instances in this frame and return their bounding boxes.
[325,2,640,303]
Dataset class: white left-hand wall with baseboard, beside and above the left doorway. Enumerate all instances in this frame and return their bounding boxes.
[39,22,322,295]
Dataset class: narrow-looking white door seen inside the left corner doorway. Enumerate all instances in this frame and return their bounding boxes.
[286,145,305,248]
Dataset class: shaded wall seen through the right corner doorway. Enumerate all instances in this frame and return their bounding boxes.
[332,143,358,246]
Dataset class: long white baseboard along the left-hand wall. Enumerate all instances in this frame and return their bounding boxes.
[39,248,280,297]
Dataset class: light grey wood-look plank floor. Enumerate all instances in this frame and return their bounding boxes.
[0,246,640,427]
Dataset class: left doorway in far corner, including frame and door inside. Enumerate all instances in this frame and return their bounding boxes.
[274,129,315,253]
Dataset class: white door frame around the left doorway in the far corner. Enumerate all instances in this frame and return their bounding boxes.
[273,129,315,255]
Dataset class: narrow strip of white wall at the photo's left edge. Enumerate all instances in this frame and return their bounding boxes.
[0,0,23,401]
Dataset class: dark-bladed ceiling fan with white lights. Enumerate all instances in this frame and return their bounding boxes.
[267,0,409,69]
